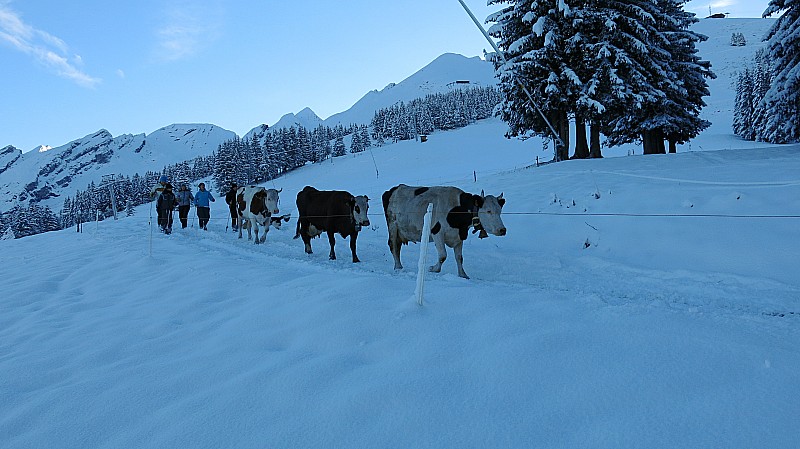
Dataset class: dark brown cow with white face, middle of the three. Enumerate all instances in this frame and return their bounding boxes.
[294,186,369,263]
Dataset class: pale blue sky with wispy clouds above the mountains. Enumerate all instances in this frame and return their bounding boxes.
[0,0,767,151]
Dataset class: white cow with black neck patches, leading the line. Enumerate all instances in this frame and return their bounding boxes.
[382,184,506,279]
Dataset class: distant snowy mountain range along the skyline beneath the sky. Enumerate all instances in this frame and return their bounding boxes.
[0,54,496,212]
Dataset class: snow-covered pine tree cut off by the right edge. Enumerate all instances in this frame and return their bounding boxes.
[761,0,800,143]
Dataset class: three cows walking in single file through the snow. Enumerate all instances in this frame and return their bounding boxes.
[231,184,506,279]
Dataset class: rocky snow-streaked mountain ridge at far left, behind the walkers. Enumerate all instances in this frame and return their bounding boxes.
[0,124,236,211]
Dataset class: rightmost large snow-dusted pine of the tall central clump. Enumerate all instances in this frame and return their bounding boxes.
[606,0,714,154]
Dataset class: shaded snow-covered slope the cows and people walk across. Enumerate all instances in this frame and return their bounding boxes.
[0,19,800,448]
